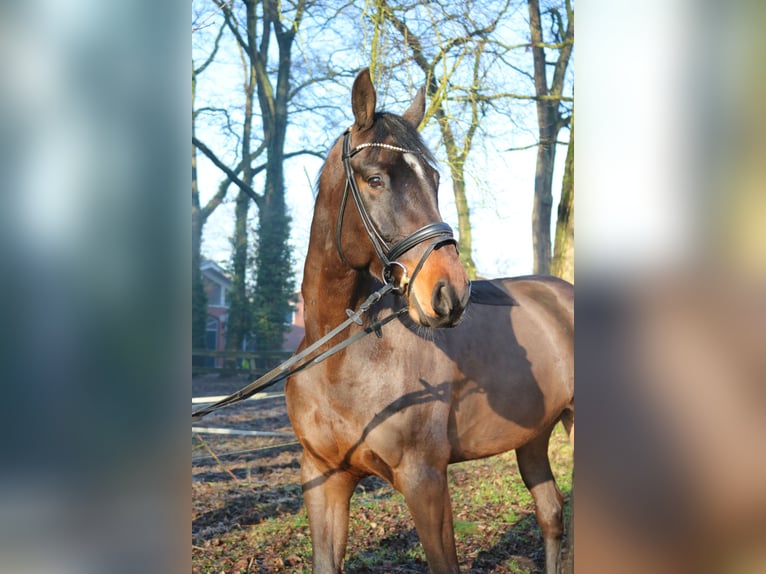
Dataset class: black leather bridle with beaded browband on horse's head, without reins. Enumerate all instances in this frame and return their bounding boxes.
[336,130,457,292]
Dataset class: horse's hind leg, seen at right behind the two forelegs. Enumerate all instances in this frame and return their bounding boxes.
[516,432,564,574]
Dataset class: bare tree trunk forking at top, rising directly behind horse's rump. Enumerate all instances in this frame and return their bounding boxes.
[528,0,574,274]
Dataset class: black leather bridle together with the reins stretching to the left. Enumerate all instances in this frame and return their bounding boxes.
[192,130,457,420]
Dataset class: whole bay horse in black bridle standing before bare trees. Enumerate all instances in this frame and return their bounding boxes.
[285,70,574,574]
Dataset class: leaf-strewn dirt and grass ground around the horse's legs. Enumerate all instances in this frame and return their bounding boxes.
[192,376,571,574]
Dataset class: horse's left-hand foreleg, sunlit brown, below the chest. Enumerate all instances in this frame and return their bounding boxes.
[301,452,359,574]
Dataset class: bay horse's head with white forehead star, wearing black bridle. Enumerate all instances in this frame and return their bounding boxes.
[320,69,470,327]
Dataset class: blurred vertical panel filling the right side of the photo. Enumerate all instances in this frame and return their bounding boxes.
[574,1,766,573]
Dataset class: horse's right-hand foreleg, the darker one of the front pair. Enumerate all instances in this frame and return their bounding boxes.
[395,465,460,574]
